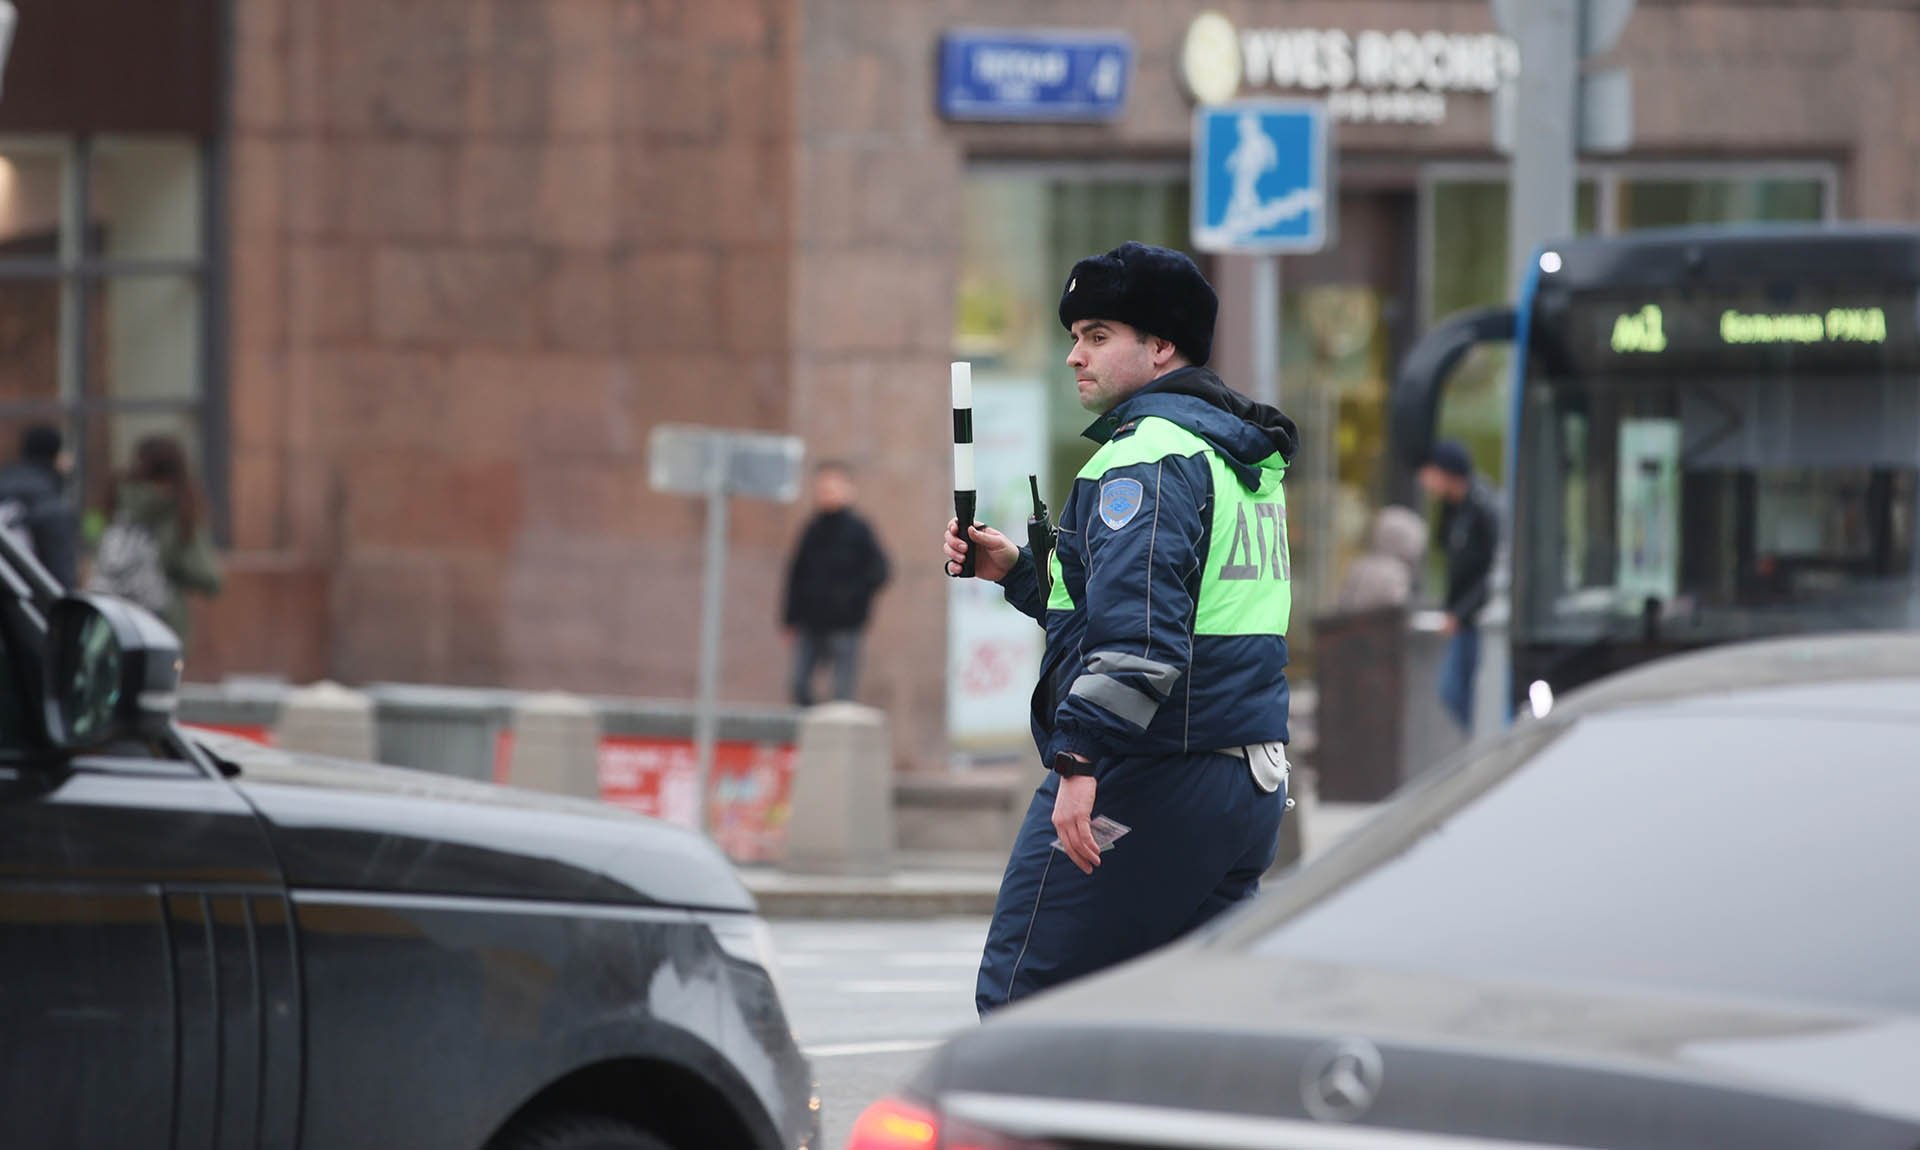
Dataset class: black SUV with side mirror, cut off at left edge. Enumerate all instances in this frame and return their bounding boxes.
[0,539,818,1150]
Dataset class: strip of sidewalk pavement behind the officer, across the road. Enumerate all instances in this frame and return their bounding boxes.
[739,803,1379,918]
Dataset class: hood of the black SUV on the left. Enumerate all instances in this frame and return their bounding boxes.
[190,730,755,912]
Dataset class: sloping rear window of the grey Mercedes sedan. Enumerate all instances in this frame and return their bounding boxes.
[1252,708,1920,1010]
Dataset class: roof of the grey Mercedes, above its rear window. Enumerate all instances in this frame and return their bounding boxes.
[1553,632,1920,720]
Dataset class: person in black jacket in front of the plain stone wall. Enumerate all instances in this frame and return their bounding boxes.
[781,461,887,707]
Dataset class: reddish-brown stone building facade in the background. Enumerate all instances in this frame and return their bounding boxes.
[0,0,1920,766]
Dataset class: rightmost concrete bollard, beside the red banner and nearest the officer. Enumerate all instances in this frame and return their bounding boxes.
[785,703,893,874]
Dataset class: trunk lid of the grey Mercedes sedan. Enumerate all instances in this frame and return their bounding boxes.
[914,945,1920,1150]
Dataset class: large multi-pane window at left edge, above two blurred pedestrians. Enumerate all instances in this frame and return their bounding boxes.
[0,136,221,545]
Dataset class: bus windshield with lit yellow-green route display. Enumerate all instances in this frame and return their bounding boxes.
[1513,284,1920,645]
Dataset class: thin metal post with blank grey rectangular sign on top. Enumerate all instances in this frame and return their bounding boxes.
[647,424,804,833]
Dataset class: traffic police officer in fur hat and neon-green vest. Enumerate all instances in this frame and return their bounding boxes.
[947,244,1298,1016]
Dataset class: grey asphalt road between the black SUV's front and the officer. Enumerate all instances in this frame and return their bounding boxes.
[772,918,987,1150]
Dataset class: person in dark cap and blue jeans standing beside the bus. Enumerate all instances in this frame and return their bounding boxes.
[1421,440,1500,733]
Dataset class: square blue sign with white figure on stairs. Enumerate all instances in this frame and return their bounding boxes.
[1192,100,1334,253]
